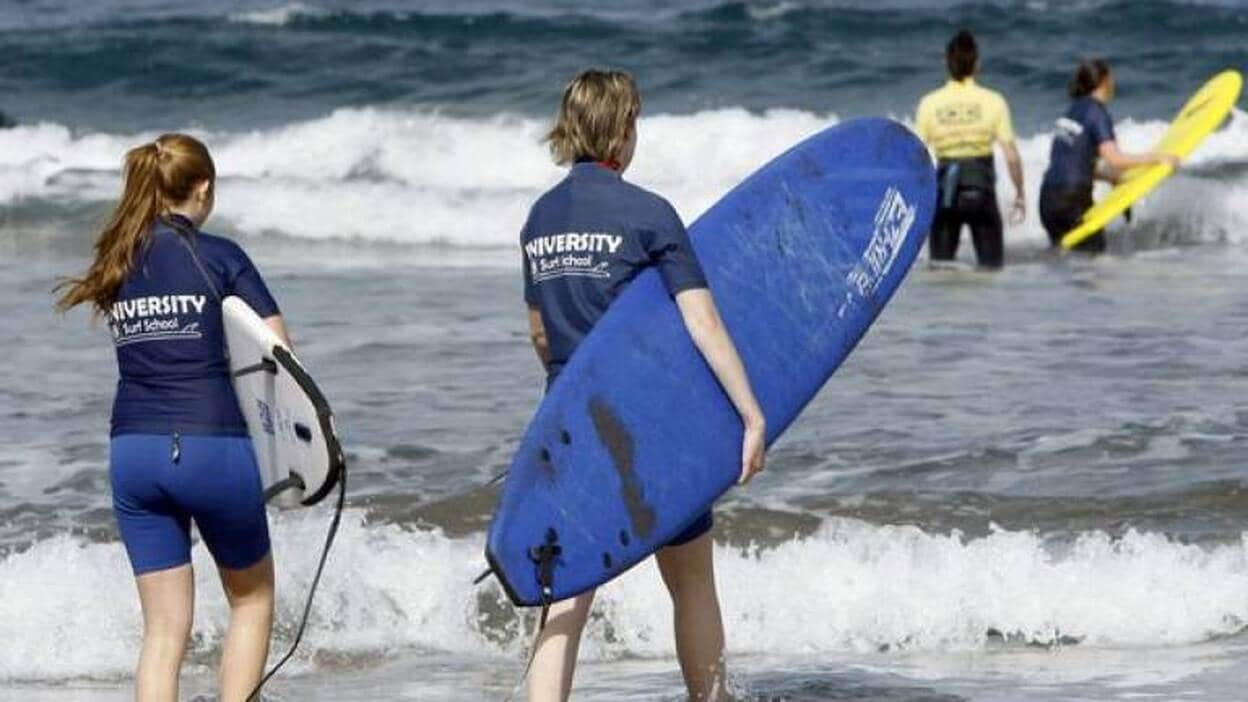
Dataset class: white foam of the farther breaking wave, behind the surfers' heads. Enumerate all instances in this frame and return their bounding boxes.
[0,109,1248,249]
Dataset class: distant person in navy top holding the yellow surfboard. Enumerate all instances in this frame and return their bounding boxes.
[1040,59,1179,254]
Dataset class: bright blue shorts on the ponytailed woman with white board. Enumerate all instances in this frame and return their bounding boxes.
[109,433,270,576]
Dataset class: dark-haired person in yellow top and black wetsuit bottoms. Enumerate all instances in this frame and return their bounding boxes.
[915,29,1027,269]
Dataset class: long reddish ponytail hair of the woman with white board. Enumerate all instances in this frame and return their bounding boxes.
[54,134,217,315]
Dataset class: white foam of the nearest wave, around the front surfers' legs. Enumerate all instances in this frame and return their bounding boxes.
[0,511,1248,680]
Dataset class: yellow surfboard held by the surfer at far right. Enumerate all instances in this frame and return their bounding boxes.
[1062,70,1243,250]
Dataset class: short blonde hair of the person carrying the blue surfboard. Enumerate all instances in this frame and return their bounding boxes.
[545,69,641,165]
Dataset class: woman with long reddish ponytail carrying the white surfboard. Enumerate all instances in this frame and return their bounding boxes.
[57,134,287,702]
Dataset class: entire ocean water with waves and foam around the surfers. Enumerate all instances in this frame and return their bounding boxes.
[0,0,1248,702]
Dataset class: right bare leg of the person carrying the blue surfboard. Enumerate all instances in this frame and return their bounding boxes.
[655,532,729,702]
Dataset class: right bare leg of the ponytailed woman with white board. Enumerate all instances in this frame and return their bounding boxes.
[218,556,273,702]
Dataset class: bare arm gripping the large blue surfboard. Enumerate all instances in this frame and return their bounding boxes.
[676,289,766,485]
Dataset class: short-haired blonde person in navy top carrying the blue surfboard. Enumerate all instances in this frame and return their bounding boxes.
[520,70,766,702]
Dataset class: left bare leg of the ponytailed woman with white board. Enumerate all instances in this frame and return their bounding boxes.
[135,563,195,702]
